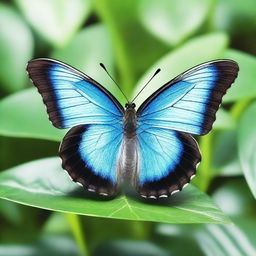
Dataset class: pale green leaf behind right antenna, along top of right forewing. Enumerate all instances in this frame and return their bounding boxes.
[134,33,228,105]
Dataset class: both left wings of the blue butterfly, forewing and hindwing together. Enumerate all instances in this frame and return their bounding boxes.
[27,59,124,195]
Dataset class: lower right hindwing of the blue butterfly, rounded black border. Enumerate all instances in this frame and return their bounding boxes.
[134,125,201,198]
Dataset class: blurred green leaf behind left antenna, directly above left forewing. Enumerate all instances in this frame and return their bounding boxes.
[51,24,123,100]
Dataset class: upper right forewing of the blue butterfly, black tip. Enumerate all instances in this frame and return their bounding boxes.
[137,60,239,135]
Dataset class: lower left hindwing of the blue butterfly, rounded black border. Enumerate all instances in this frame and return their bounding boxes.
[59,124,123,196]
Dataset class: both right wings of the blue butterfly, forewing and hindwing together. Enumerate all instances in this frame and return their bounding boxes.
[134,60,238,198]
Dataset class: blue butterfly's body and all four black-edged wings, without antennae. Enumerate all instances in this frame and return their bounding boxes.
[27,58,239,199]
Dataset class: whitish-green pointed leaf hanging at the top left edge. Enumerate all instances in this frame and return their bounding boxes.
[15,0,91,46]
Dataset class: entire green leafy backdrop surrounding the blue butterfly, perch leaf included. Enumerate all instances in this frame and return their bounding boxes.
[0,0,256,256]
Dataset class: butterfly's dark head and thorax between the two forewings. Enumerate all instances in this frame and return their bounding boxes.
[123,103,137,138]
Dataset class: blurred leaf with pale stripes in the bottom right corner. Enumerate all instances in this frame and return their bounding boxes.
[196,218,256,256]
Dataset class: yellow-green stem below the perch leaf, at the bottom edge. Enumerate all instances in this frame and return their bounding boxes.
[65,213,90,256]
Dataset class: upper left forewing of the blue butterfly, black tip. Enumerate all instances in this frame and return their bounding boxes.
[27,59,124,129]
